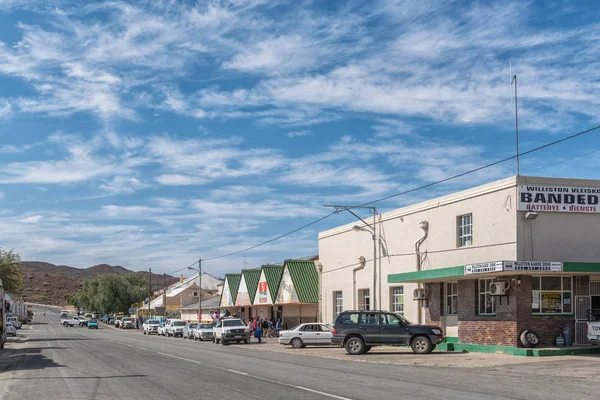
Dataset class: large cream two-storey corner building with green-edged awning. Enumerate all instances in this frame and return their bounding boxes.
[319,176,600,343]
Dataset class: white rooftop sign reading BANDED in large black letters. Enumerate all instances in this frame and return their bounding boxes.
[517,185,600,213]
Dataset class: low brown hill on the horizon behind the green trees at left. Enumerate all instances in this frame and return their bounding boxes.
[22,261,179,306]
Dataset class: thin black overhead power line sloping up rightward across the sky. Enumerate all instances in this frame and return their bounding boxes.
[169,125,600,274]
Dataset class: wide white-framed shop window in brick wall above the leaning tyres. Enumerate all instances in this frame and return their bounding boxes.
[531,276,573,314]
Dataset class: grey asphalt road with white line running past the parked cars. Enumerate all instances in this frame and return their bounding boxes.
[0,309,600,400]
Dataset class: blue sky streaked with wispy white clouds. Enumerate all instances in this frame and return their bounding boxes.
[0,0,600,274]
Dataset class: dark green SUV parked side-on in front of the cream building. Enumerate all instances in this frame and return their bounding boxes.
[331,311,445,355]
